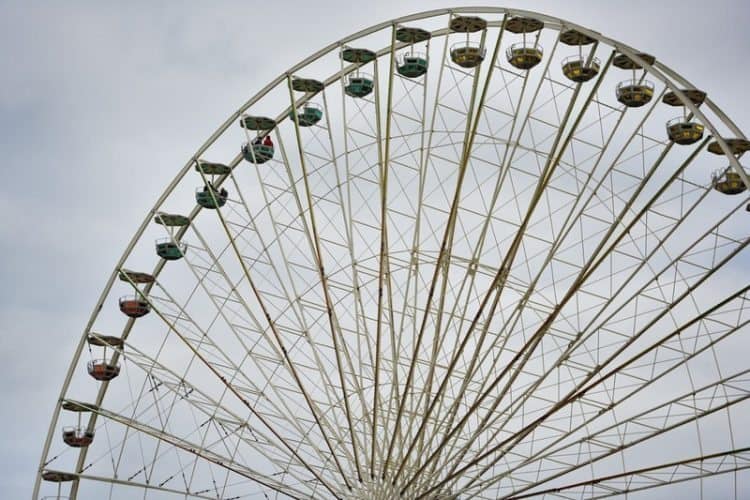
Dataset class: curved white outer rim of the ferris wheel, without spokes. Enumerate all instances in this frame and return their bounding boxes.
[34,7,750,496]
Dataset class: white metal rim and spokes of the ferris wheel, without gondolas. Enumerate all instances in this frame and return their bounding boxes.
[33,7,750,499]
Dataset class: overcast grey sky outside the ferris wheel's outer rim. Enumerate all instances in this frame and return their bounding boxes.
[0,0,750,499]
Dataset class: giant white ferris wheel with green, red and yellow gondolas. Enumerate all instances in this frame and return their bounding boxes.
[34,8,750,499]
